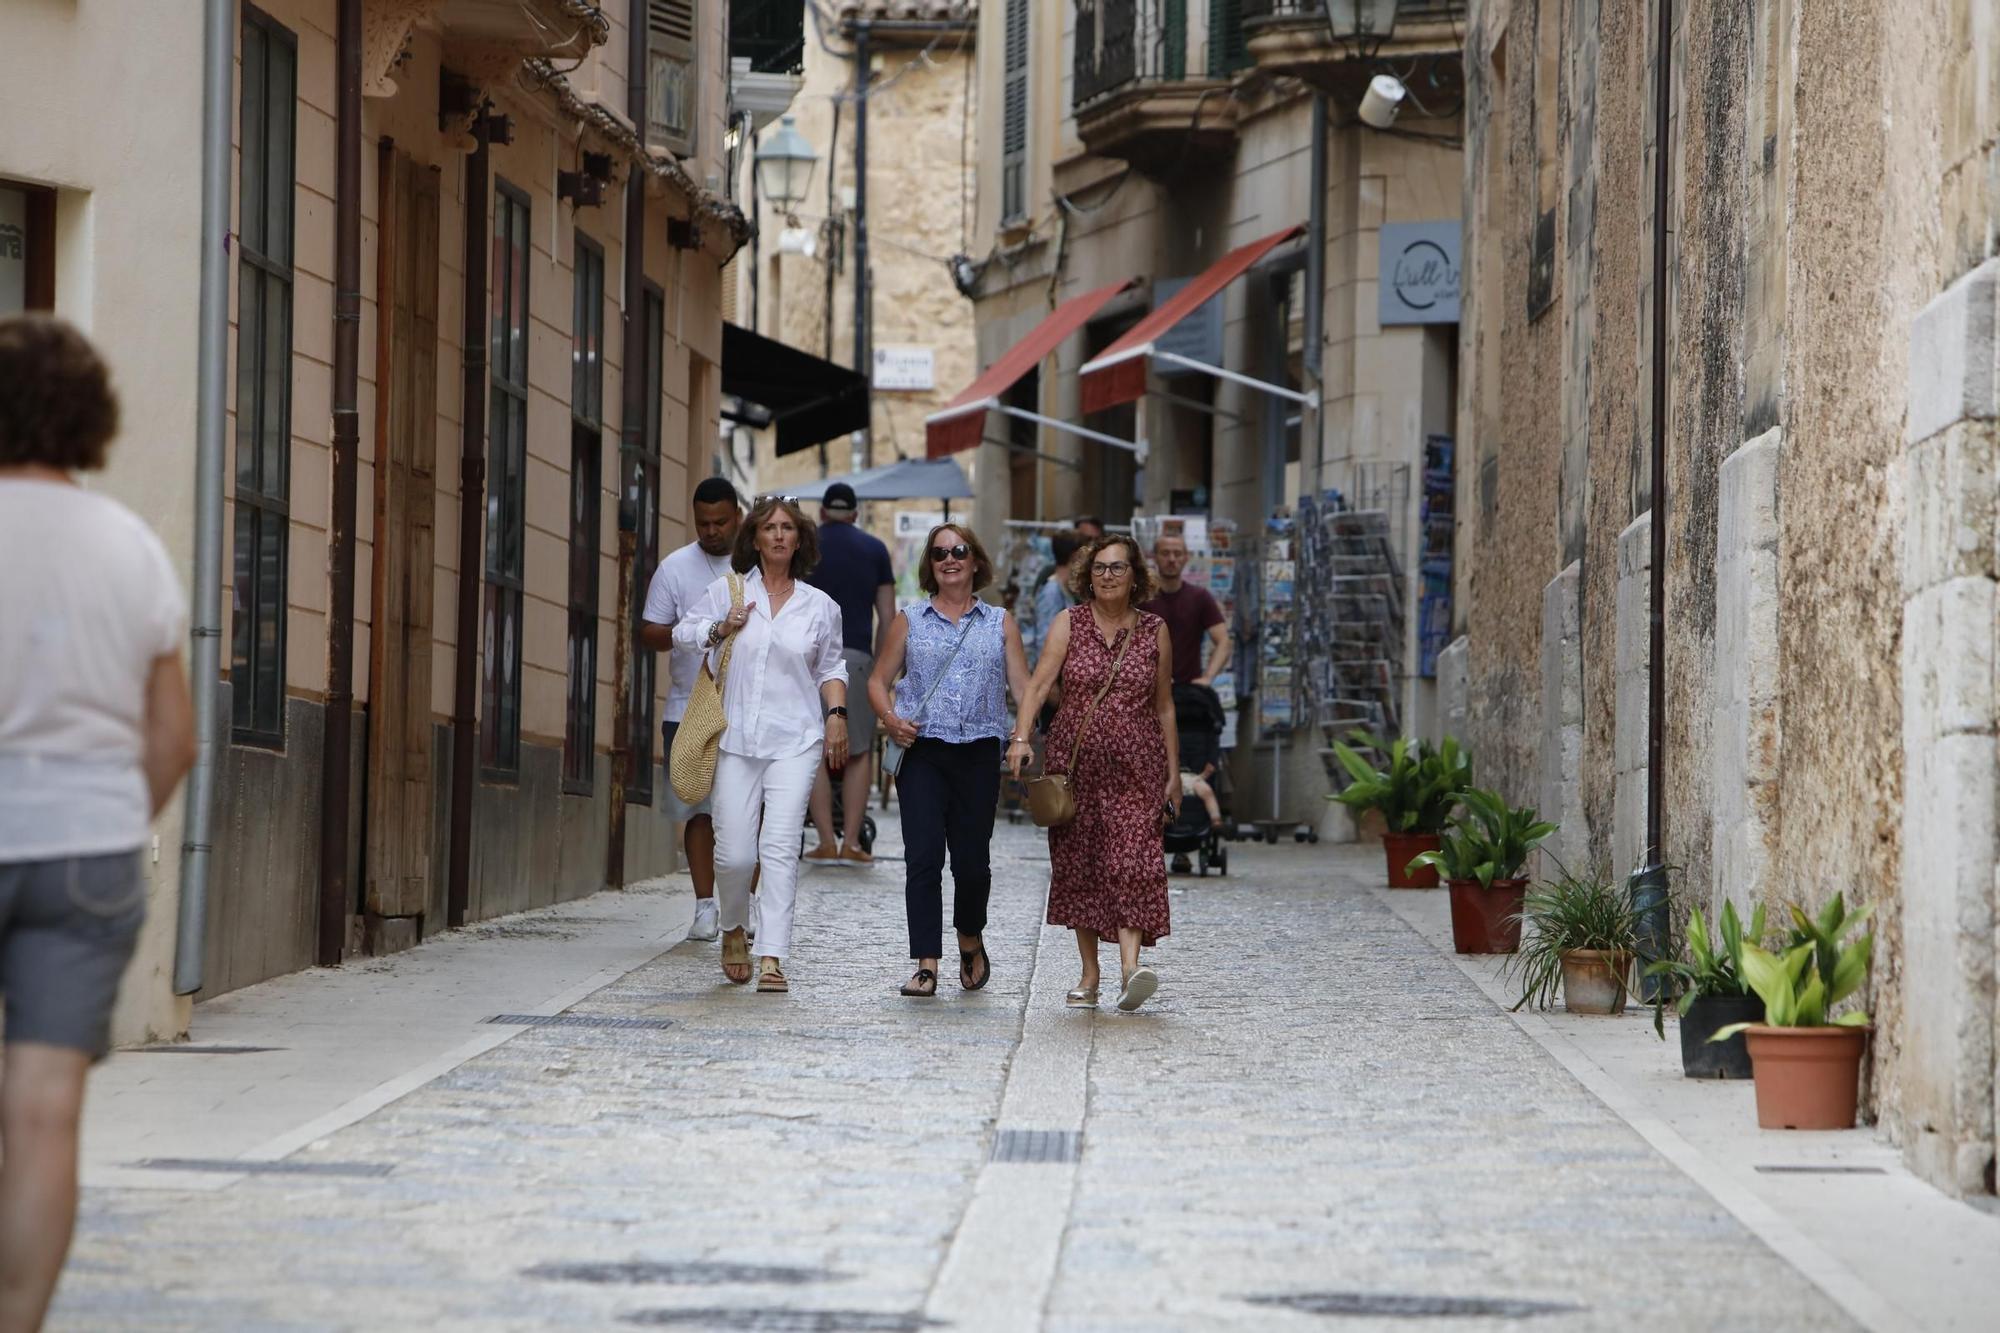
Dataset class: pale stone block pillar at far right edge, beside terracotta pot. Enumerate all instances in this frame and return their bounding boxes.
[1886,260,2000,1193]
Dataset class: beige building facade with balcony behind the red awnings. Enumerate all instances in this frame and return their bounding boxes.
[968,0,1464,825]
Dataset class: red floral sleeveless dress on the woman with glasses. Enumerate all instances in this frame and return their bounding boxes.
[1044,604,1168,945]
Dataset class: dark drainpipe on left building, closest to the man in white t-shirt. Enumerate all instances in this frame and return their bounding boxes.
[604,10,644,889]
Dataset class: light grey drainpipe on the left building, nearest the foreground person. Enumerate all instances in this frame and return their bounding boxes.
[174,0,236,995]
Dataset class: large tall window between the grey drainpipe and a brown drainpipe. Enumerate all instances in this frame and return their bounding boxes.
[230,6,298,747]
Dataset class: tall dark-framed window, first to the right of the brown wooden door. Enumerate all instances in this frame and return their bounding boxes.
[480,180,530,779]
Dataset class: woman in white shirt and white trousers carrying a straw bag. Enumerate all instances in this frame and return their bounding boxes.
[674,496,848,991]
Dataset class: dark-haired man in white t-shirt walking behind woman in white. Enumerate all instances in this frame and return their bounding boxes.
[638,476,744,939]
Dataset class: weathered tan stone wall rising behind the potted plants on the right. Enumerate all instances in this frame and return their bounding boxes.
[1446,0,2000,1193]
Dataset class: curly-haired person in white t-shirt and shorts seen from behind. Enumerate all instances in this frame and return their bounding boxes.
[0,314,194,1333]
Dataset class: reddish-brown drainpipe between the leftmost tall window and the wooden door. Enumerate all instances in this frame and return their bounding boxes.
[318,0,362,967]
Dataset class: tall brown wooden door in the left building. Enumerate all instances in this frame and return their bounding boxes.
[366,142,438,924]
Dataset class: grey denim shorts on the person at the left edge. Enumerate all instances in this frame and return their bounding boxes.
[0,853,146,1059]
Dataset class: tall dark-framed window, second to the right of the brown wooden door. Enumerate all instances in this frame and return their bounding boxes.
[562,232,604,795]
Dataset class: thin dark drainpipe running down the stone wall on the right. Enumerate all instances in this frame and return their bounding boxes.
[1632,0,1674,984]
